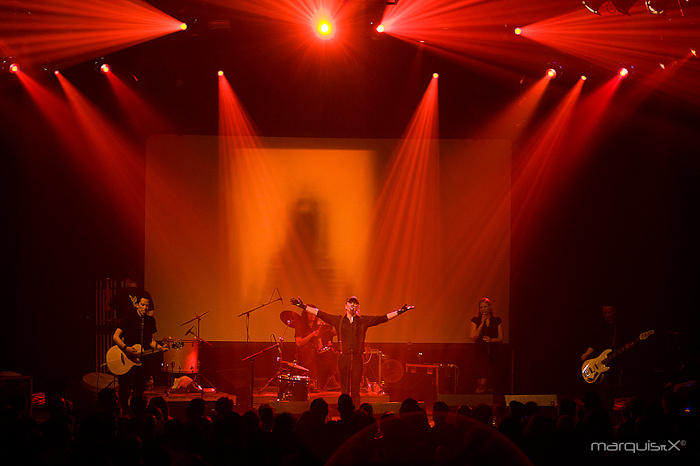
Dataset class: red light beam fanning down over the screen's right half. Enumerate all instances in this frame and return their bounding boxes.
[365,75,440,309]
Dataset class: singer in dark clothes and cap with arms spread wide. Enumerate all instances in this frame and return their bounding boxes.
[290,296,414,406]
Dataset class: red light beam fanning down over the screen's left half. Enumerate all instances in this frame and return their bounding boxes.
[219,76,328,300]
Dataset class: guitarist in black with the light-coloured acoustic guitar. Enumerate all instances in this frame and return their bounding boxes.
[112,286,163,414]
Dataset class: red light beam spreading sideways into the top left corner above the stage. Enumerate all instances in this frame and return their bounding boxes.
[0,0,183,67]
